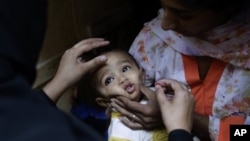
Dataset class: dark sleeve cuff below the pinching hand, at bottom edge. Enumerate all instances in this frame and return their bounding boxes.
[168,129,193,141]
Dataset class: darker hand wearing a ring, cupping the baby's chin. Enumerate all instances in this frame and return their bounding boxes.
[111,85,163,130]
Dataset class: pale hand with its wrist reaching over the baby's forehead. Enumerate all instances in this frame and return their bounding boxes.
[43,38,109,102]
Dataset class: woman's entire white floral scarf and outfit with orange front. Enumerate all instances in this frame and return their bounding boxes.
[129,9,250,140]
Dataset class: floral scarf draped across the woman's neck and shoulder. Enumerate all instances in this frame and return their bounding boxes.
[148,9,250,69]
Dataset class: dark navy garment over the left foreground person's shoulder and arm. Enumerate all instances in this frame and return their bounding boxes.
[0,91,104,141]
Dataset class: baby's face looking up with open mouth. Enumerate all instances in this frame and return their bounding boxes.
[95,52,141,100]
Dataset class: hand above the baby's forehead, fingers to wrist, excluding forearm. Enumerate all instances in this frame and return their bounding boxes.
[55,38,109,86]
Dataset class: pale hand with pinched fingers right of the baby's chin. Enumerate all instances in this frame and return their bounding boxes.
[156,79,194,133]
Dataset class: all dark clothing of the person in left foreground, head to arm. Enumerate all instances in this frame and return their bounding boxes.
[0,0,104,141]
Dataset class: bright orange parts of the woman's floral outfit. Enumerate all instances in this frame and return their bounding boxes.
[182,55,245,141]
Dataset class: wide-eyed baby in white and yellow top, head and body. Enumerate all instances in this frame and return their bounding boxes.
[81,50,167,141]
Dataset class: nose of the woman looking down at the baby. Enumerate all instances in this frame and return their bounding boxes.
[161,10,177,30]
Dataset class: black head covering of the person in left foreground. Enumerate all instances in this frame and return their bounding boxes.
[0,0,46,84]
